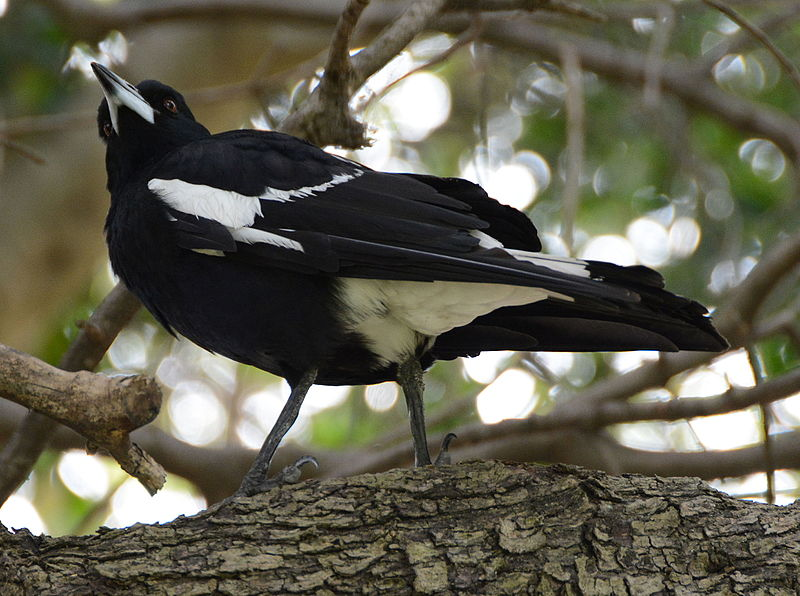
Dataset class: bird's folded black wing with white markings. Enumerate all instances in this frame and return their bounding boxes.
[149,130,636,302]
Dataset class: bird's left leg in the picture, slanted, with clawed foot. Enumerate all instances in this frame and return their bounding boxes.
[236,368,317,496]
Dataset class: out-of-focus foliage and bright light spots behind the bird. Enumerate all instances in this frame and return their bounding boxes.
[0,0,800,534]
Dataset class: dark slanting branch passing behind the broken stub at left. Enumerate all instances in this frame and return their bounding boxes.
[0,284,140,503]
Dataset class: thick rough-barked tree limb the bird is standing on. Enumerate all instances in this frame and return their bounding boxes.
[0,462,800,595]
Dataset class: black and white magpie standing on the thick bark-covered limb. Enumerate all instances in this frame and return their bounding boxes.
[92,64,727,493]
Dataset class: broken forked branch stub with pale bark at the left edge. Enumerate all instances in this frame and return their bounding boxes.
[0,345,164,493]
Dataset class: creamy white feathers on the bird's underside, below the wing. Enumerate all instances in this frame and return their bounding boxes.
[339,278,572,363]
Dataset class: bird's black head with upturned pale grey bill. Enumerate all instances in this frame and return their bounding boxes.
[92,62,210,189]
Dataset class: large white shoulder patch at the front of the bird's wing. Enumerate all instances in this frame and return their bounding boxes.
[147,178,261,229]
